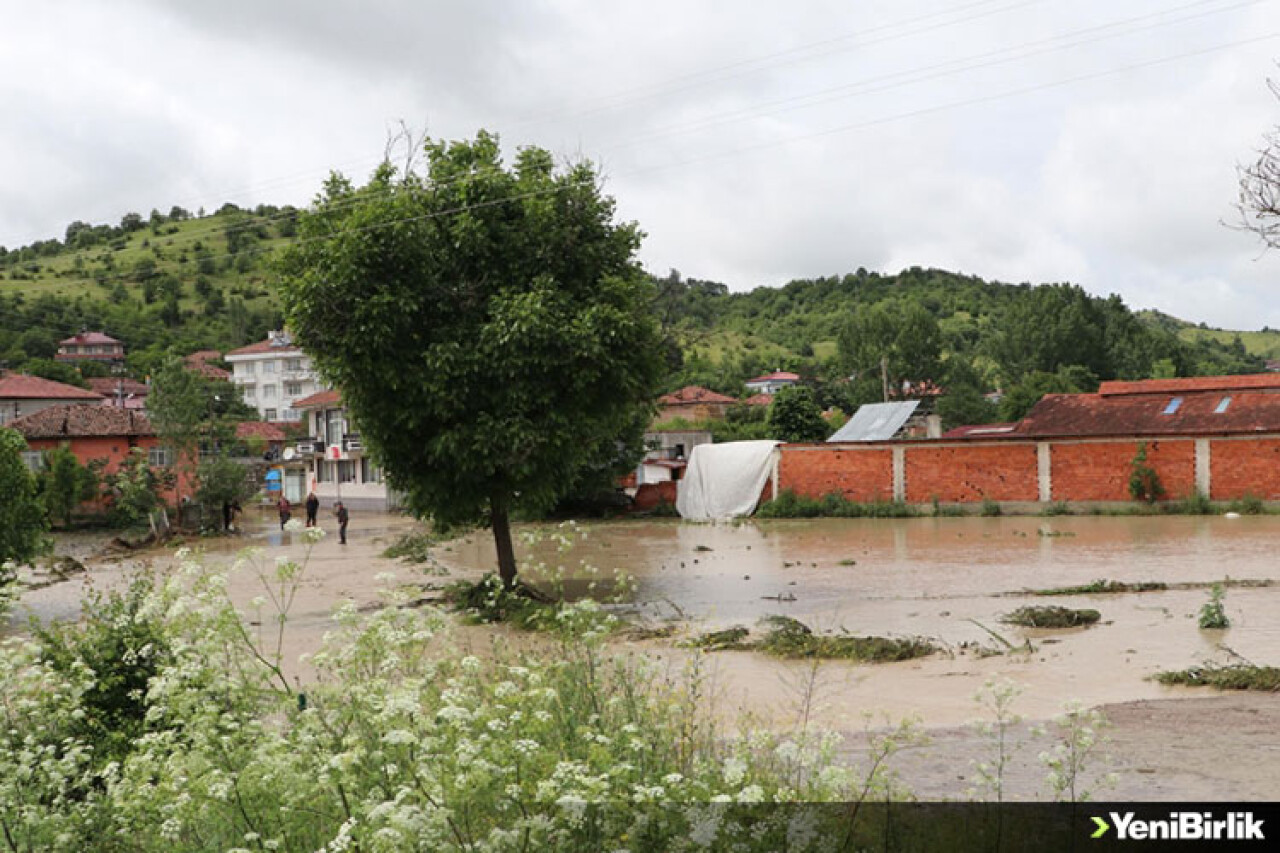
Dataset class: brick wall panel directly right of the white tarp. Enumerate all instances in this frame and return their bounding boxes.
[767,447,893,502]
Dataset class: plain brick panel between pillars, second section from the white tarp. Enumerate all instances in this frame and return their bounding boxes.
[905,444,1039,503]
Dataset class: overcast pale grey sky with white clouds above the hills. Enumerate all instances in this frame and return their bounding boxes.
[0,0,1280,329]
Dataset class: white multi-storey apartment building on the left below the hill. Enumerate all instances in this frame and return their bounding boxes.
[224,332,320,423]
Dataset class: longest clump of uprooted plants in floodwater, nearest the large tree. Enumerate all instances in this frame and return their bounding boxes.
[685,616,937,663]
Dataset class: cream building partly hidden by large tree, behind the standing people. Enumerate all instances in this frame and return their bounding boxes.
[283,391,398,510]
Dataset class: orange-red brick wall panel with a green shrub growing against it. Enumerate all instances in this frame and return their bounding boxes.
[1051,439,1196,501]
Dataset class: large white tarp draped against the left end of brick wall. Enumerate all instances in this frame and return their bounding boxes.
[676,441,780,521]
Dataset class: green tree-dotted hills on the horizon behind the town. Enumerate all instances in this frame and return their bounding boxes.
[0,204,1280,418]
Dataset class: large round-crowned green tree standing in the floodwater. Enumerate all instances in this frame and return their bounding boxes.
[282,132,663,585]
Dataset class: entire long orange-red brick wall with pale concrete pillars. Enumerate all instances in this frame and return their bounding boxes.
[763,434,1280,503]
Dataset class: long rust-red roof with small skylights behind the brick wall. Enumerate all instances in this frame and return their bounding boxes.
[1011,391,1280,438]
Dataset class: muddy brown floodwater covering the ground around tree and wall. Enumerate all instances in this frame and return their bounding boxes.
[9,514,1280,799]
